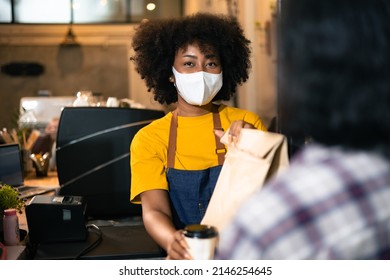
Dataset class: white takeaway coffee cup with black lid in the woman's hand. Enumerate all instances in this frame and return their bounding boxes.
[183,224,218,260]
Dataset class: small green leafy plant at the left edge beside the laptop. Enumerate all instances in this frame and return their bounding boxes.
[0,183,25,241]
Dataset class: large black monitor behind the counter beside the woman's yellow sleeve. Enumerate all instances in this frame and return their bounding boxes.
[56,107,165,219]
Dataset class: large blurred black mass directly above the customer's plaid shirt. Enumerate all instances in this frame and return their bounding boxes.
[279,0,390,155]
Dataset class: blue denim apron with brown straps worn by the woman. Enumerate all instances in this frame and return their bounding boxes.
[167,109,226,229]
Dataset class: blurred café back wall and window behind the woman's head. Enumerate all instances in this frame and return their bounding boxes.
[0,0,278,130]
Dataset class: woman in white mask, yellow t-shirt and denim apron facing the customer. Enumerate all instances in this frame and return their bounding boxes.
[130,14,266,259]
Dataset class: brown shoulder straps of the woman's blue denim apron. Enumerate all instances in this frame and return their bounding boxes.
[167,106,226,168]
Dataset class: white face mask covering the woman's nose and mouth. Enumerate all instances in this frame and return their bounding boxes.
[172,67,222,106]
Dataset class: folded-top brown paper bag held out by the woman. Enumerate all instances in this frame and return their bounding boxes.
[201,129,289,231]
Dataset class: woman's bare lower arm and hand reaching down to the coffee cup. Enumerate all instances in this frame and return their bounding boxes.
[141,190,190,259]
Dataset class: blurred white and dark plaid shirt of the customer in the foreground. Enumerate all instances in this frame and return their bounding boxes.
[216,144,390,260]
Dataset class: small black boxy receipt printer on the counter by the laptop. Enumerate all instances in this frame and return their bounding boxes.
[26,195,87,244]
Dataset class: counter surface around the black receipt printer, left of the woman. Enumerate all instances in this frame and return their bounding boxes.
[7,172,165,260]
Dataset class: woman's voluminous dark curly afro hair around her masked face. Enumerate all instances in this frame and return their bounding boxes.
[131,13,251,104]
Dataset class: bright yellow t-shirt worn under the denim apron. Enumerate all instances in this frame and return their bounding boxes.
[130,105,267,203]
